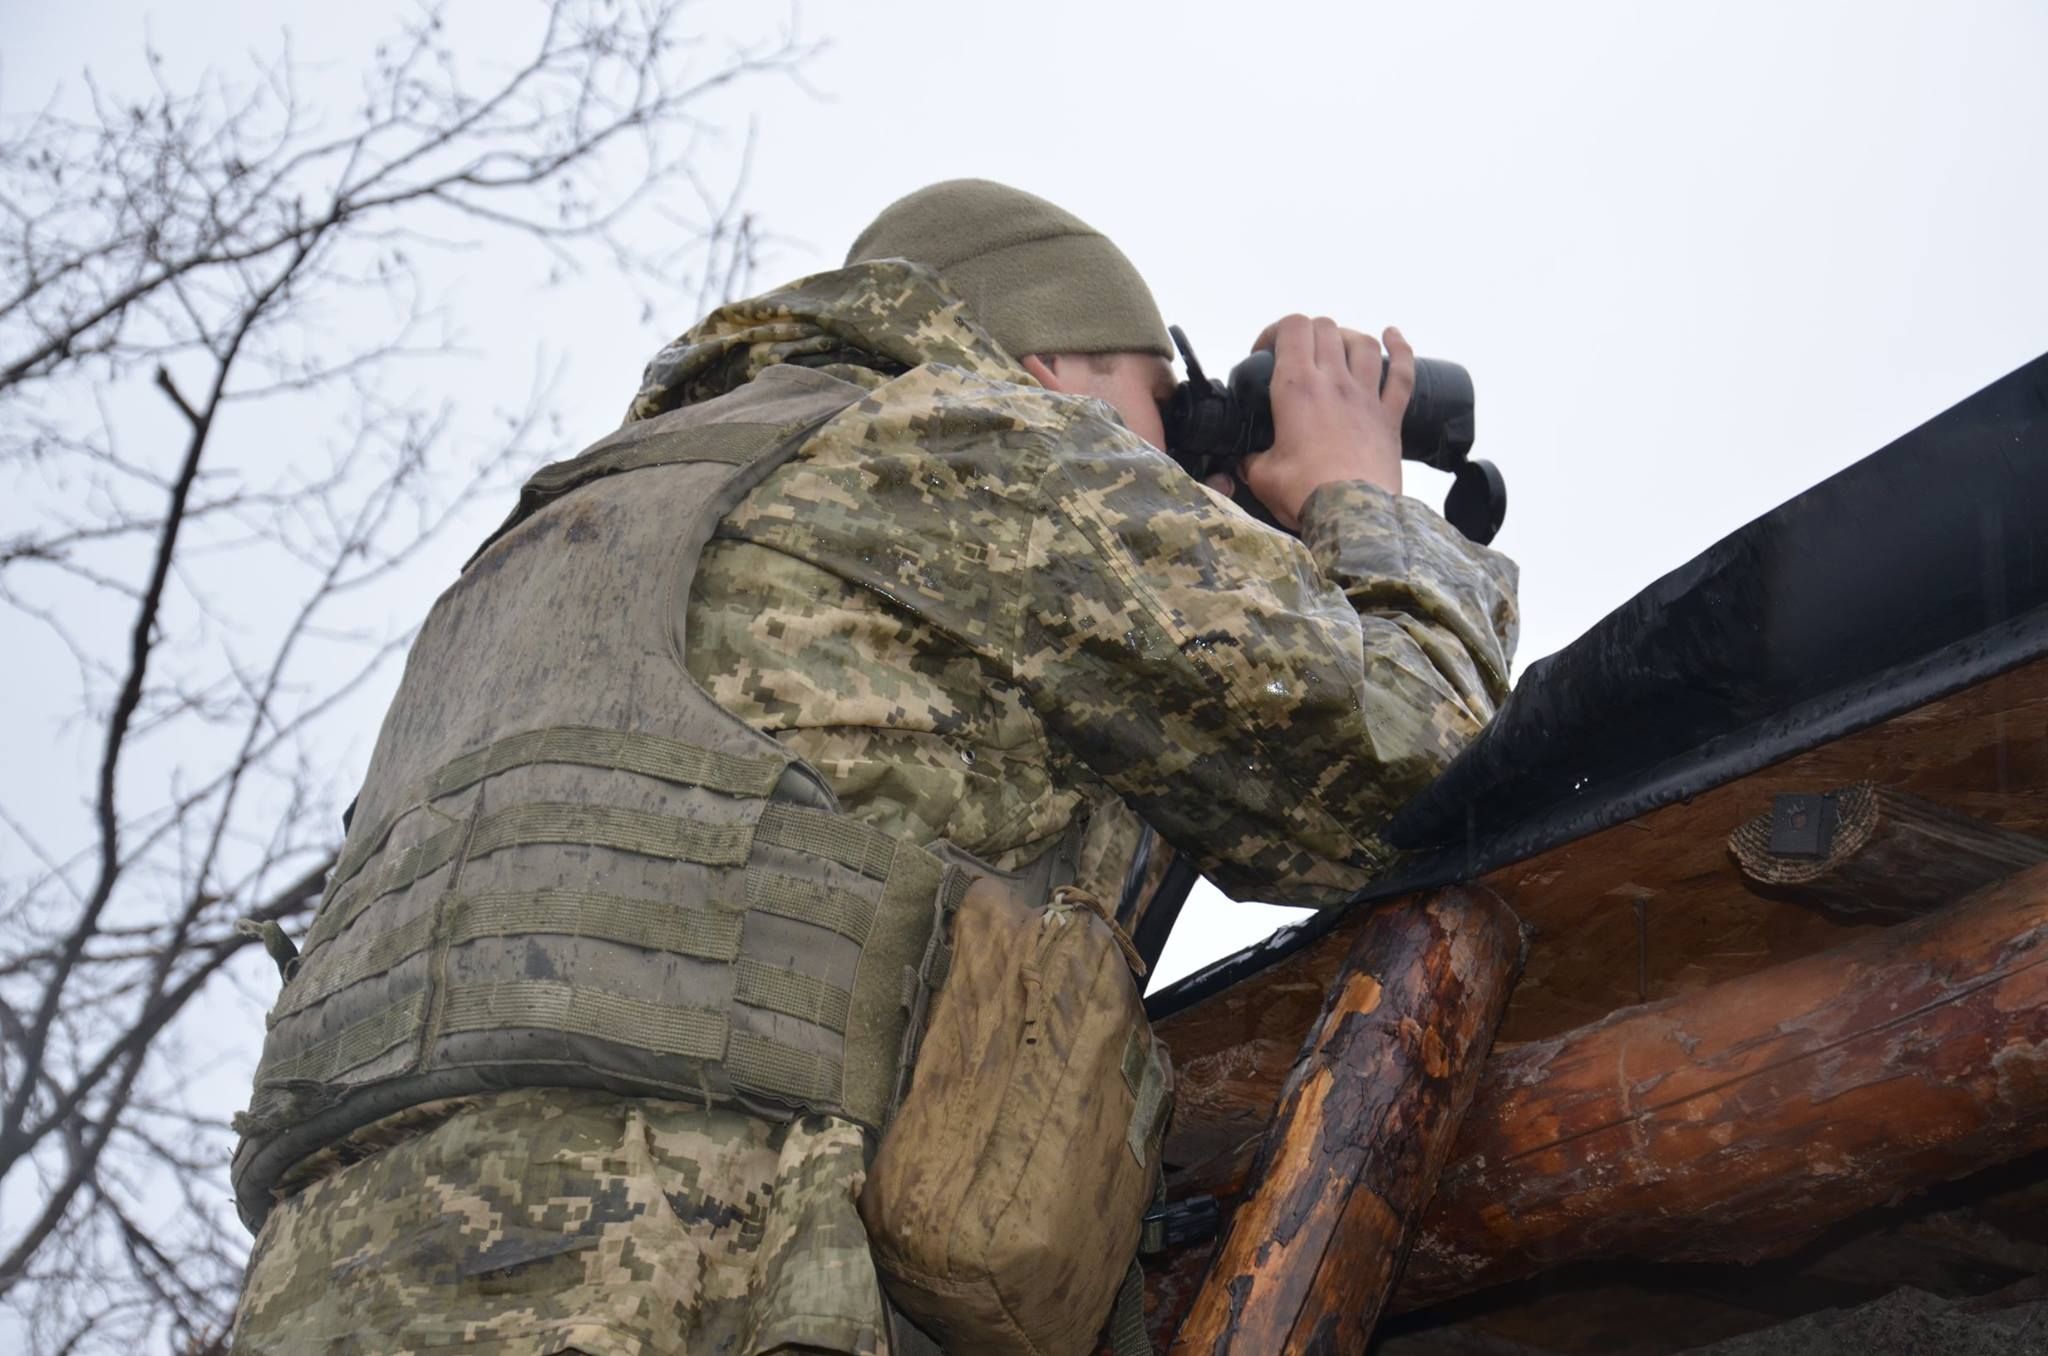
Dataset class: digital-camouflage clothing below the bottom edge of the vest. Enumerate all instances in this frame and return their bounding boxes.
[231,1090,901,1356]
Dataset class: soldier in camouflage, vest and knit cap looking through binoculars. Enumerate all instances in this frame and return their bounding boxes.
[233,180,1516,1356]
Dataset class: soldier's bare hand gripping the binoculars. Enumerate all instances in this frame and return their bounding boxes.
[1241,315,1415,531]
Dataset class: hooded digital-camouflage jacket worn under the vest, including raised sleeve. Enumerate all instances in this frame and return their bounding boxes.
[629,262,1516,905]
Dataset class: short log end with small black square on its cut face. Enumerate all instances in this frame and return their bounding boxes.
[1729,782,2048,918]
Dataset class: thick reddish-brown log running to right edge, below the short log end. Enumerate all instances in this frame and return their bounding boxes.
[1395,866,2048,1309]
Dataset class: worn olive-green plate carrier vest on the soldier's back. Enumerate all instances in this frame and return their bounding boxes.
[233,367,967,1229]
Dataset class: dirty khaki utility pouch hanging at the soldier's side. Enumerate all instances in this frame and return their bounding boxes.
[860,879,1171,1356]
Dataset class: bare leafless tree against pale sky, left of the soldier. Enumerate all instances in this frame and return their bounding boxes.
[0,0,809,1352]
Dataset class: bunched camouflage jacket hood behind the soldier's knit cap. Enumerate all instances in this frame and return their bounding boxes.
[627,258,1036,424]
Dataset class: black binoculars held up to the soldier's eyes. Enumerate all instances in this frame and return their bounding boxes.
[1159,326,1507,545]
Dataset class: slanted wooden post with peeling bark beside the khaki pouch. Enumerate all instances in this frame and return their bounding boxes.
[1174,889,1522,1356]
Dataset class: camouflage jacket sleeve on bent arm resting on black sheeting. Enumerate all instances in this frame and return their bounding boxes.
[1014,414,1516,905]
